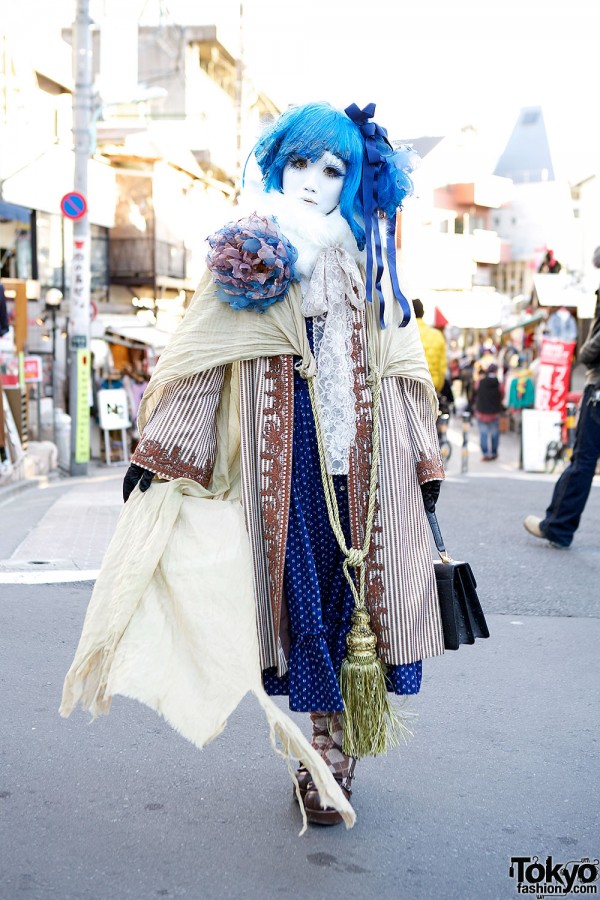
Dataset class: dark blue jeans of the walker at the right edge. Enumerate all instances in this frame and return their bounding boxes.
[540,384,600,547]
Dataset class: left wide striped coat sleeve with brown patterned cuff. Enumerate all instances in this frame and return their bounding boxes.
[132,366,225,487]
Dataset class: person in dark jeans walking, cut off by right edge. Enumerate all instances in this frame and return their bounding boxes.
[523,247,600,549]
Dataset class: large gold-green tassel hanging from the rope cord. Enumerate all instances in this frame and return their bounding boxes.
[340,607,411,758]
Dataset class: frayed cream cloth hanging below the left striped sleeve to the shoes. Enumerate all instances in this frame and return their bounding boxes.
[60,479,355,833]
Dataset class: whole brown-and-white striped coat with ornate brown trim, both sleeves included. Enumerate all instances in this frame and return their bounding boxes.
[133,346,444,674]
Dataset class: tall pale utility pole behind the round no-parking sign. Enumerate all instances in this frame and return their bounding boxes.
[69,0,93,475]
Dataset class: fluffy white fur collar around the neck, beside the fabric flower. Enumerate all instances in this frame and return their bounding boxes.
[237,183,365,281]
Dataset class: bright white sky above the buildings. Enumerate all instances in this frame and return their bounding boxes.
[9,0,600,181]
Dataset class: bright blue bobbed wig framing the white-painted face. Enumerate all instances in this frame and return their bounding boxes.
[254,103,414,250]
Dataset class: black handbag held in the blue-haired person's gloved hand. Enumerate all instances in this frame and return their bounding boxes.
[426,511,490,650]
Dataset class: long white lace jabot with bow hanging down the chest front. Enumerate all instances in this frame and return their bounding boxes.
[302,247,365,475]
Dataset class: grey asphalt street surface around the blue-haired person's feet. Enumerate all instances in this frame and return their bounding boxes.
[0,441,600,900]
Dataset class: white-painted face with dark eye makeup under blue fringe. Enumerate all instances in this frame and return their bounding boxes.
[281,151,346,216]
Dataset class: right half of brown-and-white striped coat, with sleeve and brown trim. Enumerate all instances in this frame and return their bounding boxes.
[348,310,444,665]
